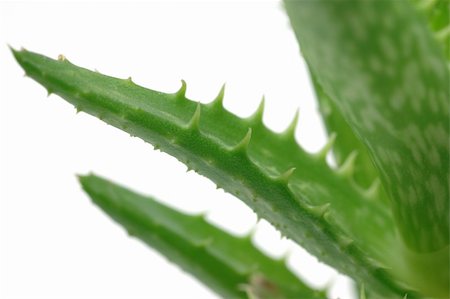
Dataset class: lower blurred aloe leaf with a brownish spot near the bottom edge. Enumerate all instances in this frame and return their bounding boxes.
[79,175,326,299]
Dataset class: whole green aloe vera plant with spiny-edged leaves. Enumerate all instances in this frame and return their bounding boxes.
[13,0,450,298]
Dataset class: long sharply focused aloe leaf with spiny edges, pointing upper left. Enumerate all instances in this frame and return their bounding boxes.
[13,50,414,297]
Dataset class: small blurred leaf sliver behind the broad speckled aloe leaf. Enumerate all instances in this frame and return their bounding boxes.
[311,73,382,192]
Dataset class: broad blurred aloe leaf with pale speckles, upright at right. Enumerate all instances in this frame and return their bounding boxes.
[285,0,449,255]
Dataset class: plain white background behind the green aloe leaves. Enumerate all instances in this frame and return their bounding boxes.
[0,1,352,299]
